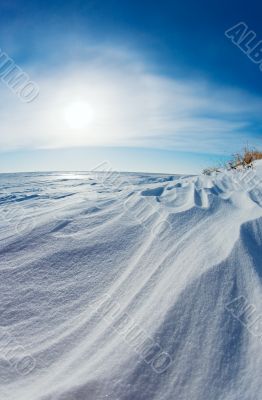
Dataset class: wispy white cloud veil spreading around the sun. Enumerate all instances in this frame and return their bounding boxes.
[0,46,262,154]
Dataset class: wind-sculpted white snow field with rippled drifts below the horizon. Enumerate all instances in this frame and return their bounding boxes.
[0,163,262,400]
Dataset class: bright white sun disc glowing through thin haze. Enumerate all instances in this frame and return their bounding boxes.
[63,100,94,129]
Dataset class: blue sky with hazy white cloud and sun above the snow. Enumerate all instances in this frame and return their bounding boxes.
[0,0,262,173]
